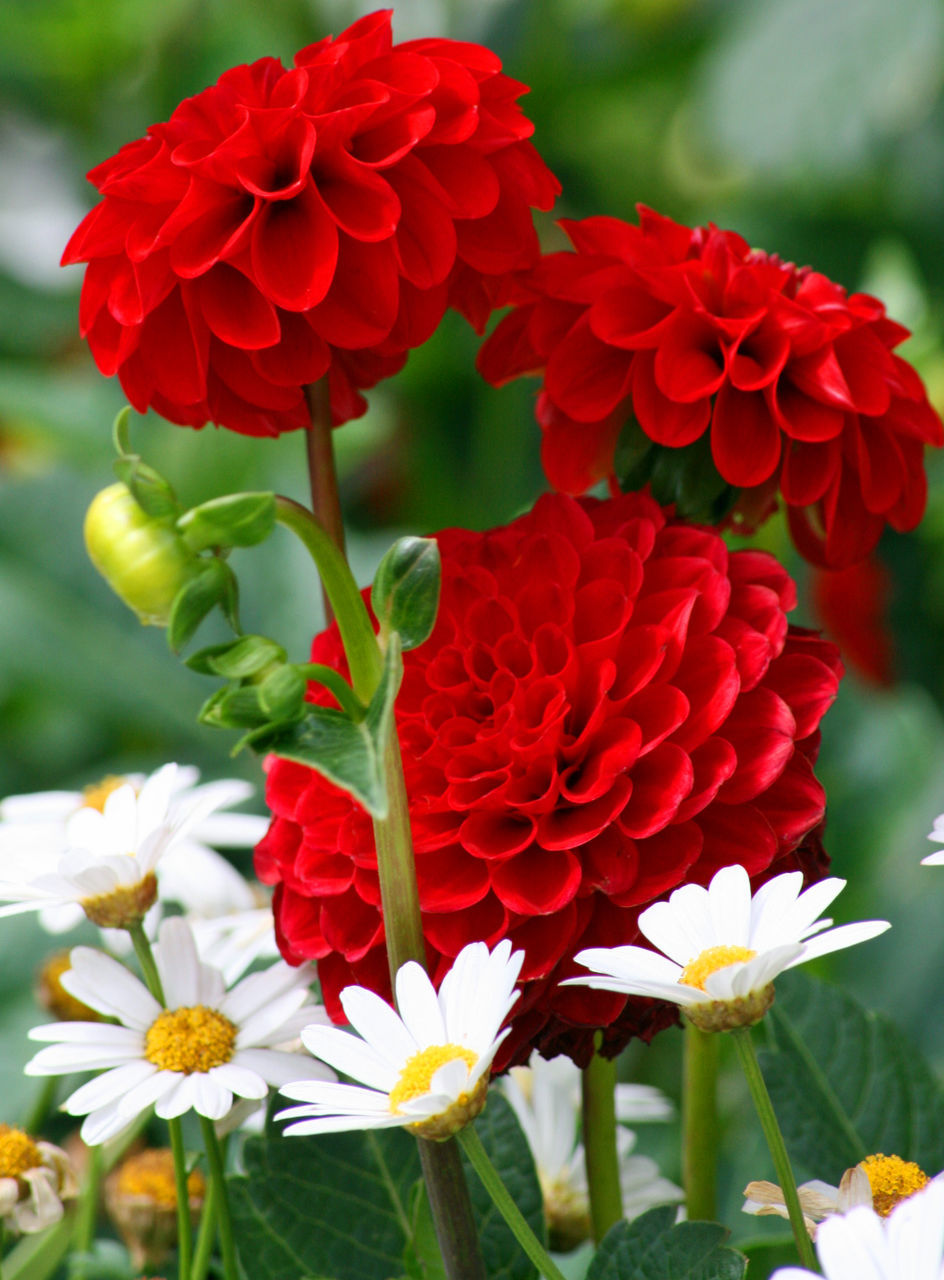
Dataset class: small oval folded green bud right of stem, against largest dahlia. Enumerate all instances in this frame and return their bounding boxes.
[371,538,441,650]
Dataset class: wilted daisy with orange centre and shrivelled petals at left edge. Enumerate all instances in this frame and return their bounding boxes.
[0,1124,78,1233]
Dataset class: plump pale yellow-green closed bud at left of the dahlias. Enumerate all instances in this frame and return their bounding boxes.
[84,484,201,627]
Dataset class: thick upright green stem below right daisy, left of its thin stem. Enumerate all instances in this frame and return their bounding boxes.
[682,1023,718,1222]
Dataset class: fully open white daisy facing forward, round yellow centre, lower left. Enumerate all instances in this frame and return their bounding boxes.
[24,916,334,1146]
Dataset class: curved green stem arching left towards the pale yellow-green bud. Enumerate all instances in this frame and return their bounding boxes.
[275,495,384,703]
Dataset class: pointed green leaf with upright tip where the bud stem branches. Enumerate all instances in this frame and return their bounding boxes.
[265,634,403,818]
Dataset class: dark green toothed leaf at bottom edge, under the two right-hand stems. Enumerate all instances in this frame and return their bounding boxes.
[587,1204,747,1280]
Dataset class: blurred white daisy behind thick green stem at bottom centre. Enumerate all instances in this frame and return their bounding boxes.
[499,1053,683,1253]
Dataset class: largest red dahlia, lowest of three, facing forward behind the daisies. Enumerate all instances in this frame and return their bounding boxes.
[256,494,842,1068]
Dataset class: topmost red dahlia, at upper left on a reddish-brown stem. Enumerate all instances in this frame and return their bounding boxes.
[63,10,559,435]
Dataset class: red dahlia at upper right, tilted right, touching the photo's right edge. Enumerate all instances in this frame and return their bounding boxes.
[480,206,944,567]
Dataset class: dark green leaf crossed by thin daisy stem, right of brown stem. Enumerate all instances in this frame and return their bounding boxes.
[462,1089,547,1280]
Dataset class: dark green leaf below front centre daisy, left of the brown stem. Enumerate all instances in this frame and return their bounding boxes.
[229,1129,420,1280]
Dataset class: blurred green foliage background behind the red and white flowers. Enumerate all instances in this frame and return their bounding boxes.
[0,0,944,1249]
